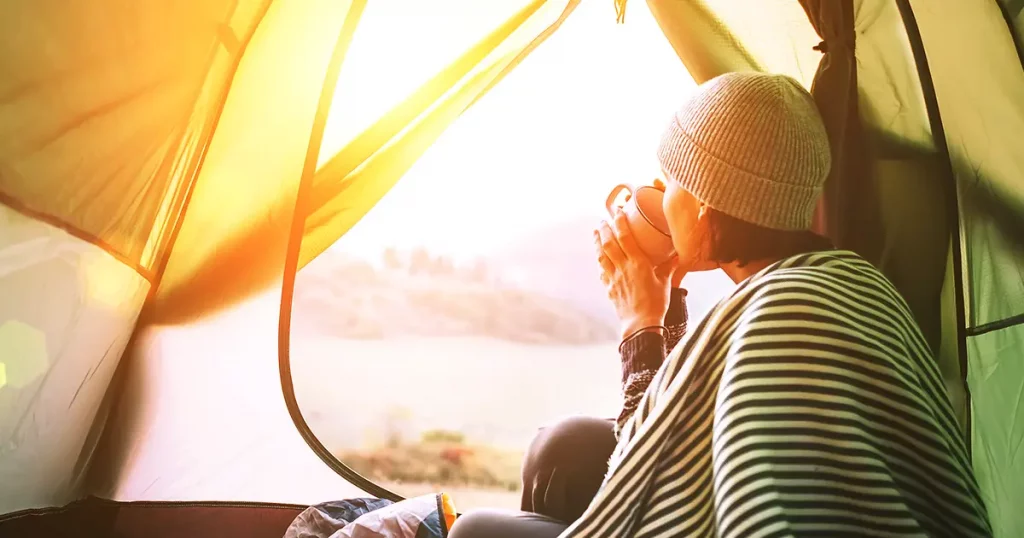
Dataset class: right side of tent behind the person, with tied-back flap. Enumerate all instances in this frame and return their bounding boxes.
[648,0,1024,536]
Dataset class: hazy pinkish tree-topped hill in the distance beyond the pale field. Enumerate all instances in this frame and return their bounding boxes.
[293,246,617,344]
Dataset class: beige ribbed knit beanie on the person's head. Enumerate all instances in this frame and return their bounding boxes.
[657,72,831,230]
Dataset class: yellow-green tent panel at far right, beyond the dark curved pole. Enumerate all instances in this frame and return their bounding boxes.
[909,1,1024,536]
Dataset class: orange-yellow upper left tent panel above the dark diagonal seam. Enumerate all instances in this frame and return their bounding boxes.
[0,0,268,272]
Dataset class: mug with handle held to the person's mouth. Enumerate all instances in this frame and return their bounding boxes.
[604,183,675,265]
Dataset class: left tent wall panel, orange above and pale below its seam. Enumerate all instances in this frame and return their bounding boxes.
[0,0,269,511]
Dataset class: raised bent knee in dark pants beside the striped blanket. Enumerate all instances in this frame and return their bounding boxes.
[521,417,615,523]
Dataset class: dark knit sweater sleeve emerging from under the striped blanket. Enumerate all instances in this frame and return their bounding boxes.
[615,288,687,437]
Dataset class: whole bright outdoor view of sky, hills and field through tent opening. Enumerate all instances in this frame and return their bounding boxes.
[290,0,731,509]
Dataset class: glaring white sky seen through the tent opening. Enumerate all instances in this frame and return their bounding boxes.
[325,0,693,257]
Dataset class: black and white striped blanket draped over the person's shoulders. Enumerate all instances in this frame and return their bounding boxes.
[562,251,991,538]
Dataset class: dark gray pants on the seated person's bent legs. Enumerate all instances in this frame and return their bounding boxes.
[449,417,615,538]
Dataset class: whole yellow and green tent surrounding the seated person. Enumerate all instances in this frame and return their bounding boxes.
[0,0,1024,537]
